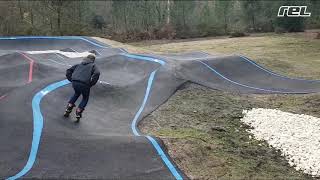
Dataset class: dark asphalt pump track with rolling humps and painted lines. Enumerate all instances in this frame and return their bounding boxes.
[0,37,320,179]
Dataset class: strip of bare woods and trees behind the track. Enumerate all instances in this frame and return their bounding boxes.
[0,0,320,41]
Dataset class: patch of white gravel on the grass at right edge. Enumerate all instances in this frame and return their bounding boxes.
[241,108,320,177]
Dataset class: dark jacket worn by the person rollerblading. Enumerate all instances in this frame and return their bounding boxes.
[66,58,100,87]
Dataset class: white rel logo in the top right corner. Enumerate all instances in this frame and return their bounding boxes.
[278,6,311,17]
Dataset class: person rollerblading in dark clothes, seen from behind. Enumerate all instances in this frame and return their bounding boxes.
[64,54,100,123]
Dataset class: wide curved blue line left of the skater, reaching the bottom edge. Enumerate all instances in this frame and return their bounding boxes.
[8,80,70,180]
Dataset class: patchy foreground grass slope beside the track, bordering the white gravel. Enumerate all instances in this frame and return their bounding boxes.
[139,84,320,179]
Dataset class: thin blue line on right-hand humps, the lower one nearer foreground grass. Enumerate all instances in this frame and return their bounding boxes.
[197,60,310,94]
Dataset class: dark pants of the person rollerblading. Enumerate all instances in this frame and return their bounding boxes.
[69,81,90,110]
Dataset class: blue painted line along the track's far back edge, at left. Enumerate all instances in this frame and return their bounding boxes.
[0,36,109,48]
